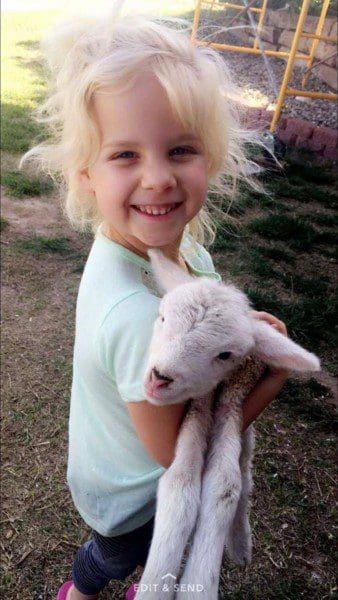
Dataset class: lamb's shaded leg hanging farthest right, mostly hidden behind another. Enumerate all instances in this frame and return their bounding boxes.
[226,425,255,566]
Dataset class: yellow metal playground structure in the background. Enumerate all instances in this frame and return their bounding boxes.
[191,0,338,133]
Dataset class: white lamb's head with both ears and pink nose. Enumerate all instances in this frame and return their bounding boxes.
[144,249,319,405]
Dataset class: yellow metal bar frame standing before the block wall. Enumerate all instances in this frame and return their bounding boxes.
[191,0,338,132]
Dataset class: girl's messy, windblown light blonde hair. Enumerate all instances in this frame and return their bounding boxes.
[20,9,257,245]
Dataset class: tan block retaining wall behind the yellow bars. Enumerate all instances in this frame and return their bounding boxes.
[232,10,338,90]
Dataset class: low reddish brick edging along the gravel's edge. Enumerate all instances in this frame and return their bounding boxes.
[243,107,338,162]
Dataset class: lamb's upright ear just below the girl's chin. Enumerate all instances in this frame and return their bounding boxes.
[148,248,194,293]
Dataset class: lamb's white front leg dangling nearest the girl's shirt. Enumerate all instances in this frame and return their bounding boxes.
[136,394,212,600]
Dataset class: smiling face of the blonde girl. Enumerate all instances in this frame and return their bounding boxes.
[80,74,207,256]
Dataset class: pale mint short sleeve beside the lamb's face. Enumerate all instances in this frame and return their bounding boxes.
[96,291,161,402]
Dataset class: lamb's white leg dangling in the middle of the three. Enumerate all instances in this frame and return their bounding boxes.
[176,402,241,600]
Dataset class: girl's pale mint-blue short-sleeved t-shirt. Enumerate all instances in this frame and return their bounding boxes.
[67,228,220,537]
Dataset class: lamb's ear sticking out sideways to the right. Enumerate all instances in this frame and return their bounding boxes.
[252,318,320,371]
